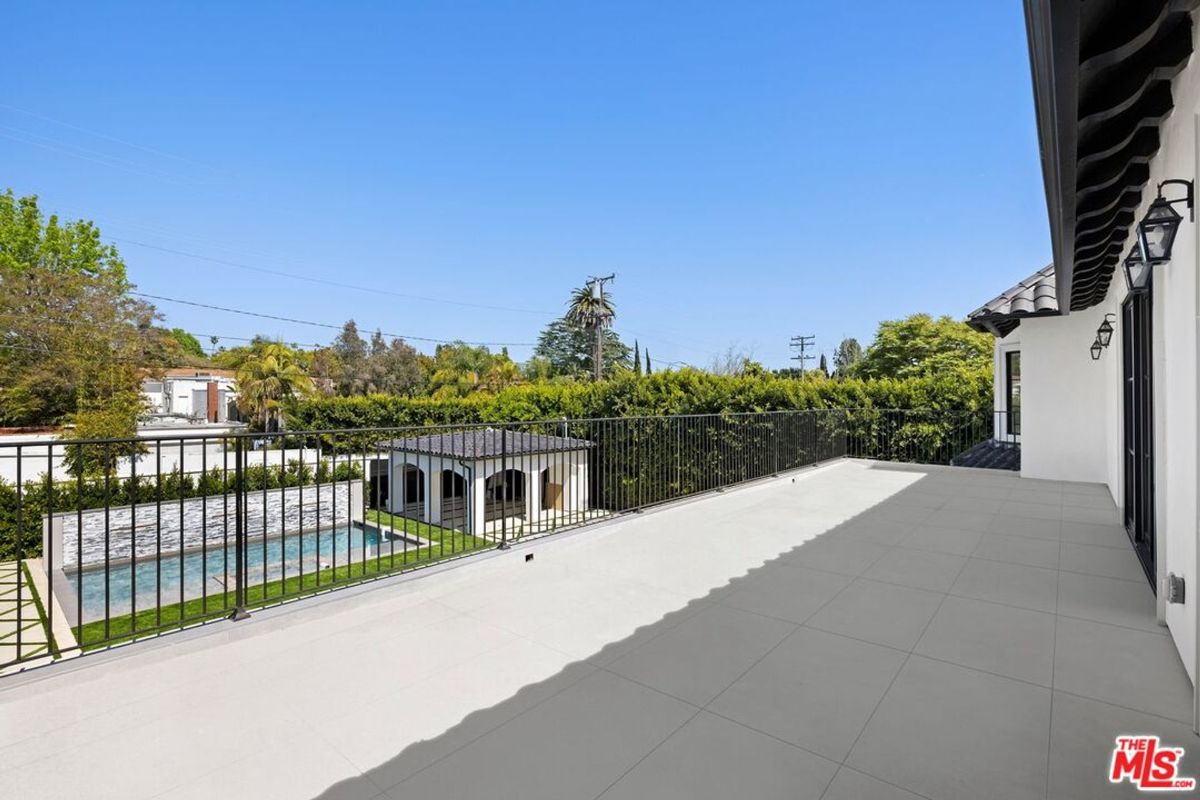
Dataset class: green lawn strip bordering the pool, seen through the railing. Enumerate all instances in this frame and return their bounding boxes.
[77,510,496,651]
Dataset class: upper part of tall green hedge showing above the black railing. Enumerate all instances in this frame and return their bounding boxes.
[288,369,992,431]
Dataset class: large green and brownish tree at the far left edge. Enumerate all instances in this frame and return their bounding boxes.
[0,191,169,429]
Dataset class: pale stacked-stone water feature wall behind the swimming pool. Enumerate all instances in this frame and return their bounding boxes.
[43,481,362,570]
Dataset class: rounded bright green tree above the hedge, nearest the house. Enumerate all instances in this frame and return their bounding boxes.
[854,314,992,378]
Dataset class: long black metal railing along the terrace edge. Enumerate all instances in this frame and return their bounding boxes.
[0,409,992,666]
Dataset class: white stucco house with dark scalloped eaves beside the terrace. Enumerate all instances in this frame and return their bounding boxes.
[971,0,1200,730]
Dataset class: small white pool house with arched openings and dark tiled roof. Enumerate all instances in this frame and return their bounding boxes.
[381,428,594,535]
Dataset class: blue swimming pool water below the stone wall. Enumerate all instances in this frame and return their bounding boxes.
[60,525,393,622]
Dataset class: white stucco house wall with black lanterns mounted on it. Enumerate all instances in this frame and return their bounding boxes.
[1020,18,1200,681]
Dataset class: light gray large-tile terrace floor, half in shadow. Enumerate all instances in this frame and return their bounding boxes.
[0,462,1200,800]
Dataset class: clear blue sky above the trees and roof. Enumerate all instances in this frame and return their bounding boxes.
[0,0,1050,366]
